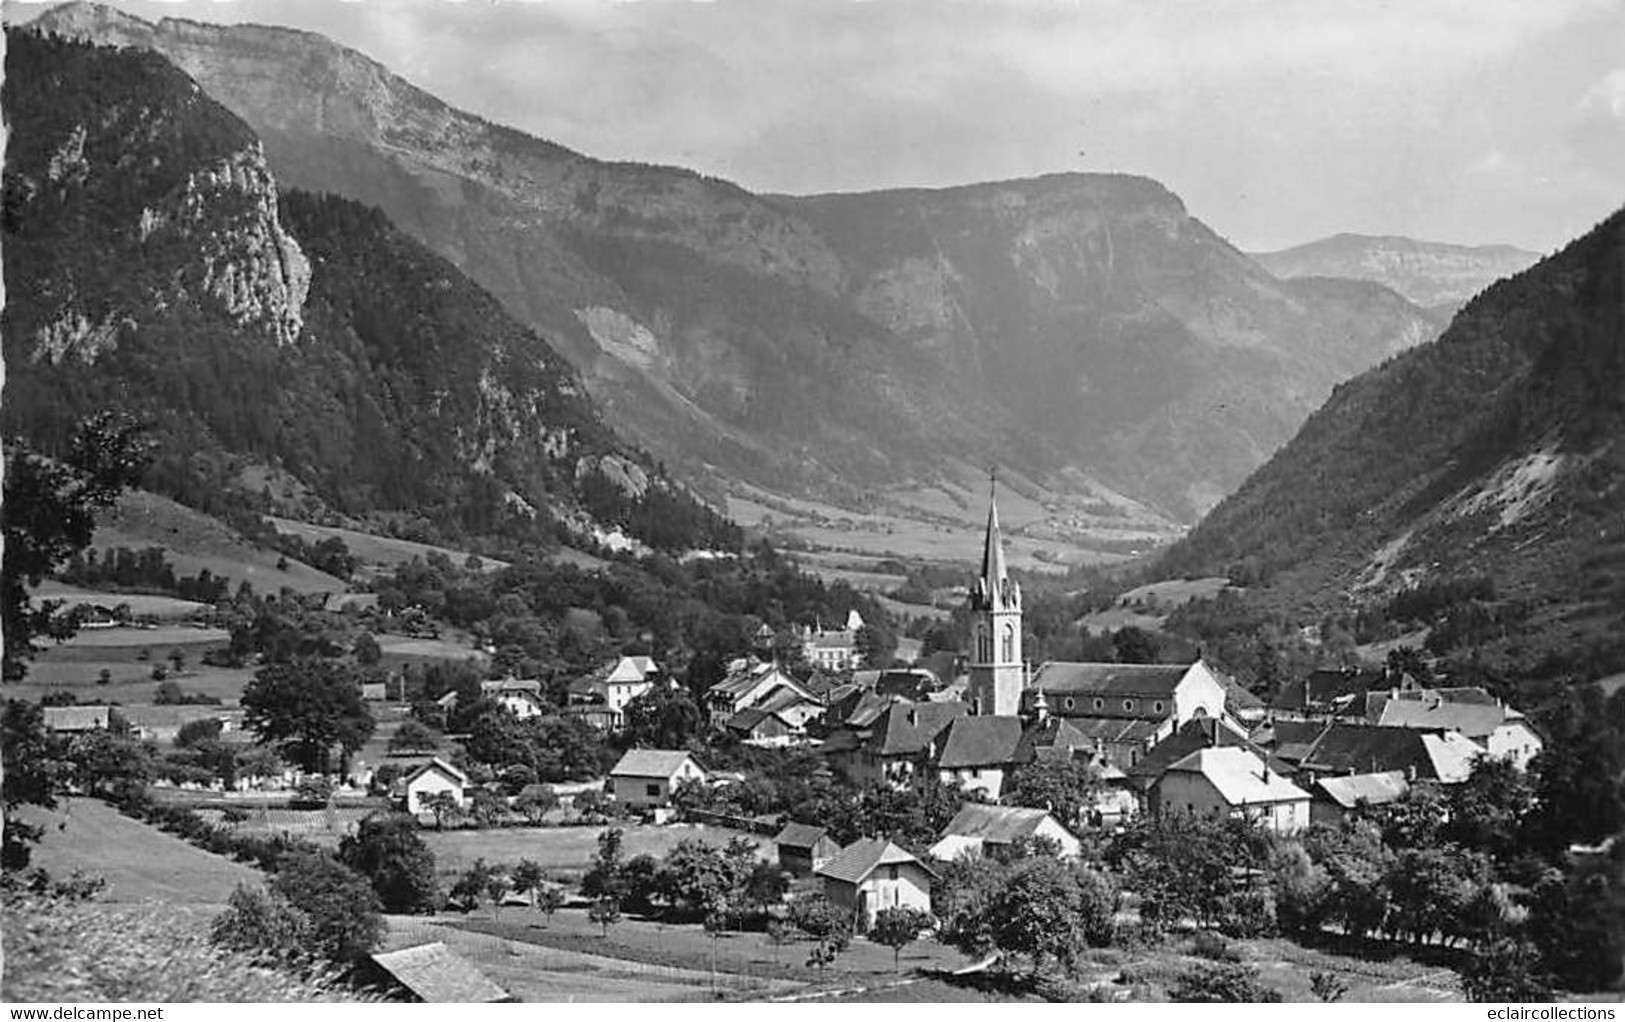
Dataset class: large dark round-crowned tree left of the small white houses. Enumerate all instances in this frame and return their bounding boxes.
[239,658,374,773]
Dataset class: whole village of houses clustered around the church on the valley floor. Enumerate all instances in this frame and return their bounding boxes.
[12,484,1586,999]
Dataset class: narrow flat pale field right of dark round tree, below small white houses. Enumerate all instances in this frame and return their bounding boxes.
[423,824,769,874]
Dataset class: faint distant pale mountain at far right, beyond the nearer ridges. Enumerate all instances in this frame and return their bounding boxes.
[1253,234,1541,310]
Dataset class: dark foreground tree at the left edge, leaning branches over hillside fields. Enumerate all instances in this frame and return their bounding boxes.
[0,413,151,681]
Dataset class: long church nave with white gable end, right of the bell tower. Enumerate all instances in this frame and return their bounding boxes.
[1027,660,1227,770]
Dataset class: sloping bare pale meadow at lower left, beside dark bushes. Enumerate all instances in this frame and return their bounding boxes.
[24,798,265,908]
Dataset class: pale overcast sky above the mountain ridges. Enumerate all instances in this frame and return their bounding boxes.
[7,0,1625,250]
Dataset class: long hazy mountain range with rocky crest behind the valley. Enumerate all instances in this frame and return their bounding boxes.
[39,5,1430,530]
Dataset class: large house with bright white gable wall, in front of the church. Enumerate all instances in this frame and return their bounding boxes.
[1149,746,1310,834]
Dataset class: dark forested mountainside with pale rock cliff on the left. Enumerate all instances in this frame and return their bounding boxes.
[3,31,736,548]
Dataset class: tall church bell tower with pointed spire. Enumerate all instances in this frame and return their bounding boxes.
[970,479,1025,717]
